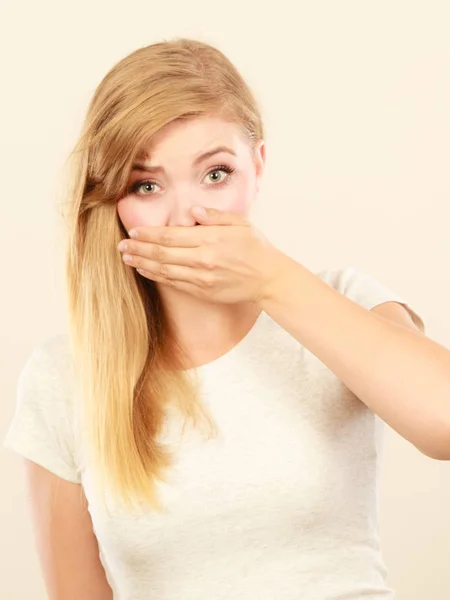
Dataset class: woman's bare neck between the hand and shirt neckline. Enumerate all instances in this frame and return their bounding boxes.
[158,286,261,368]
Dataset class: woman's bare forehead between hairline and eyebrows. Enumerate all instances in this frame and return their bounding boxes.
[138,117,248,162]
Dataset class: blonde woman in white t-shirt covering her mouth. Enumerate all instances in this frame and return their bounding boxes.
[6,40,450,600]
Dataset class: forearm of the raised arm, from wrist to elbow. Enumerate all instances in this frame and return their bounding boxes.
[260,257,450,459]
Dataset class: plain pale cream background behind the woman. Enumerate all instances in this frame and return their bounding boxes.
[0,0,450,600]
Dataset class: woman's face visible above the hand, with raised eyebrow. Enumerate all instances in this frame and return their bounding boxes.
[117,117,264,231]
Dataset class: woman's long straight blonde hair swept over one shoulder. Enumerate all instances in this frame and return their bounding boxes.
[66,39,263,508]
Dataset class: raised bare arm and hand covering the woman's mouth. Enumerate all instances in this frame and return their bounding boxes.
[118,120,450,460]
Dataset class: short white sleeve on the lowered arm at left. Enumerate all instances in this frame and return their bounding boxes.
[4,336,81,483]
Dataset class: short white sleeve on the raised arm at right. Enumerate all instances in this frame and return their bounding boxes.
[319,267,425,332]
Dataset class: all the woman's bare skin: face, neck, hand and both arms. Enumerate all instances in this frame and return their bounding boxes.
[28,119,450,600]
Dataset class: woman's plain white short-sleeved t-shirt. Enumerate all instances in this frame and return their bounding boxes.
[5,267,420,600]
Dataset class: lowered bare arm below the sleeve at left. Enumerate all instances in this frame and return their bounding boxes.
[26,460,113,600]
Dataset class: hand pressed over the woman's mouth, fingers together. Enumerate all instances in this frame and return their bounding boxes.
[118,208,287,303]
